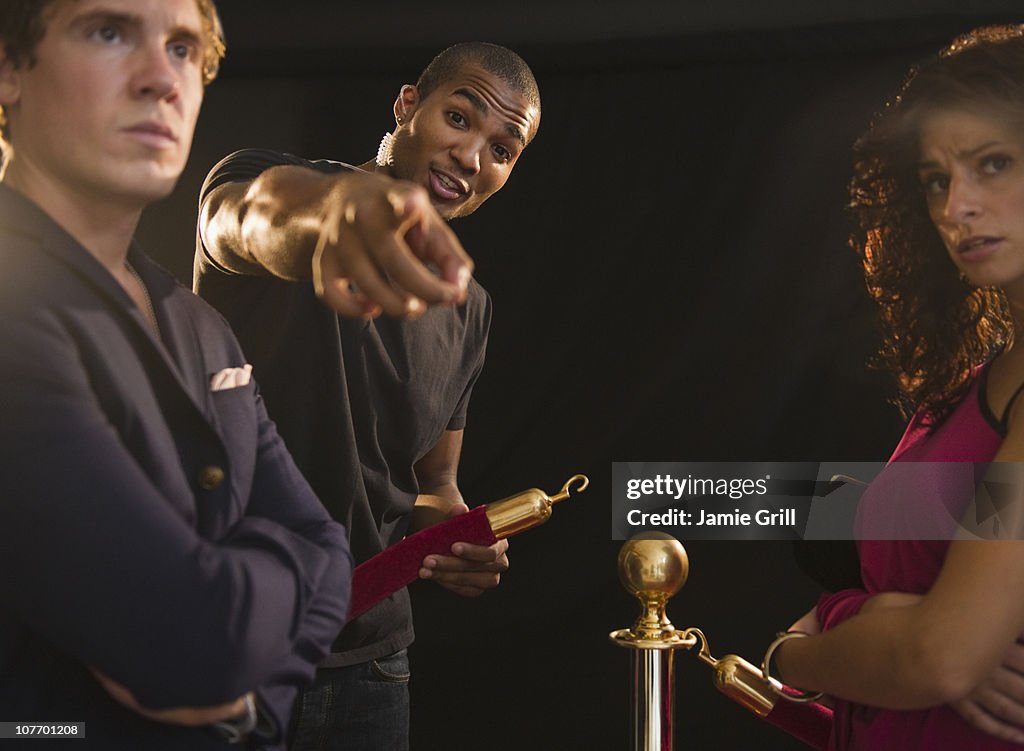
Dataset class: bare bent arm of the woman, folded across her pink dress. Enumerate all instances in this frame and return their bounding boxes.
[776,422,1024,709]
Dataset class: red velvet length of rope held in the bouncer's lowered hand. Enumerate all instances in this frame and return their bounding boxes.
[348,506,498,621]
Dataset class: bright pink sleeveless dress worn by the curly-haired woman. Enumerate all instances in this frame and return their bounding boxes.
[818,366,1022,751]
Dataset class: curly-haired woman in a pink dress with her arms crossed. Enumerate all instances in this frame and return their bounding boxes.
[766,27,1024,750]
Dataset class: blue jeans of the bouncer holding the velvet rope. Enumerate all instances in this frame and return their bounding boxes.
[288,650,409,751]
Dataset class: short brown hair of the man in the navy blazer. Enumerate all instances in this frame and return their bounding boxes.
[0,0,225,145]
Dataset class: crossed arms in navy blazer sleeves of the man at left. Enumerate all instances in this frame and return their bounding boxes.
[0,310,350,727]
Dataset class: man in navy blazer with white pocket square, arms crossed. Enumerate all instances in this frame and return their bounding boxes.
[0,0,364,751]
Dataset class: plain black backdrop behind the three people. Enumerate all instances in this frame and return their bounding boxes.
[141,7,1015,751]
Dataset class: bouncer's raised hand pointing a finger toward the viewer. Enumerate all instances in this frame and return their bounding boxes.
[312,173,473,318]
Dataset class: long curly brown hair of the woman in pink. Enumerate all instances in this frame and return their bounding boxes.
[850,25,1024,424]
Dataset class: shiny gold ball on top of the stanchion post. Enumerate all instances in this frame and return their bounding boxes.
[618,532,690,599]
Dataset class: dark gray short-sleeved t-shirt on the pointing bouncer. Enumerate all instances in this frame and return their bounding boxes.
[195,149,490,667]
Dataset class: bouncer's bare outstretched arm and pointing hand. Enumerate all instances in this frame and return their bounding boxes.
[200,152,473,317]
